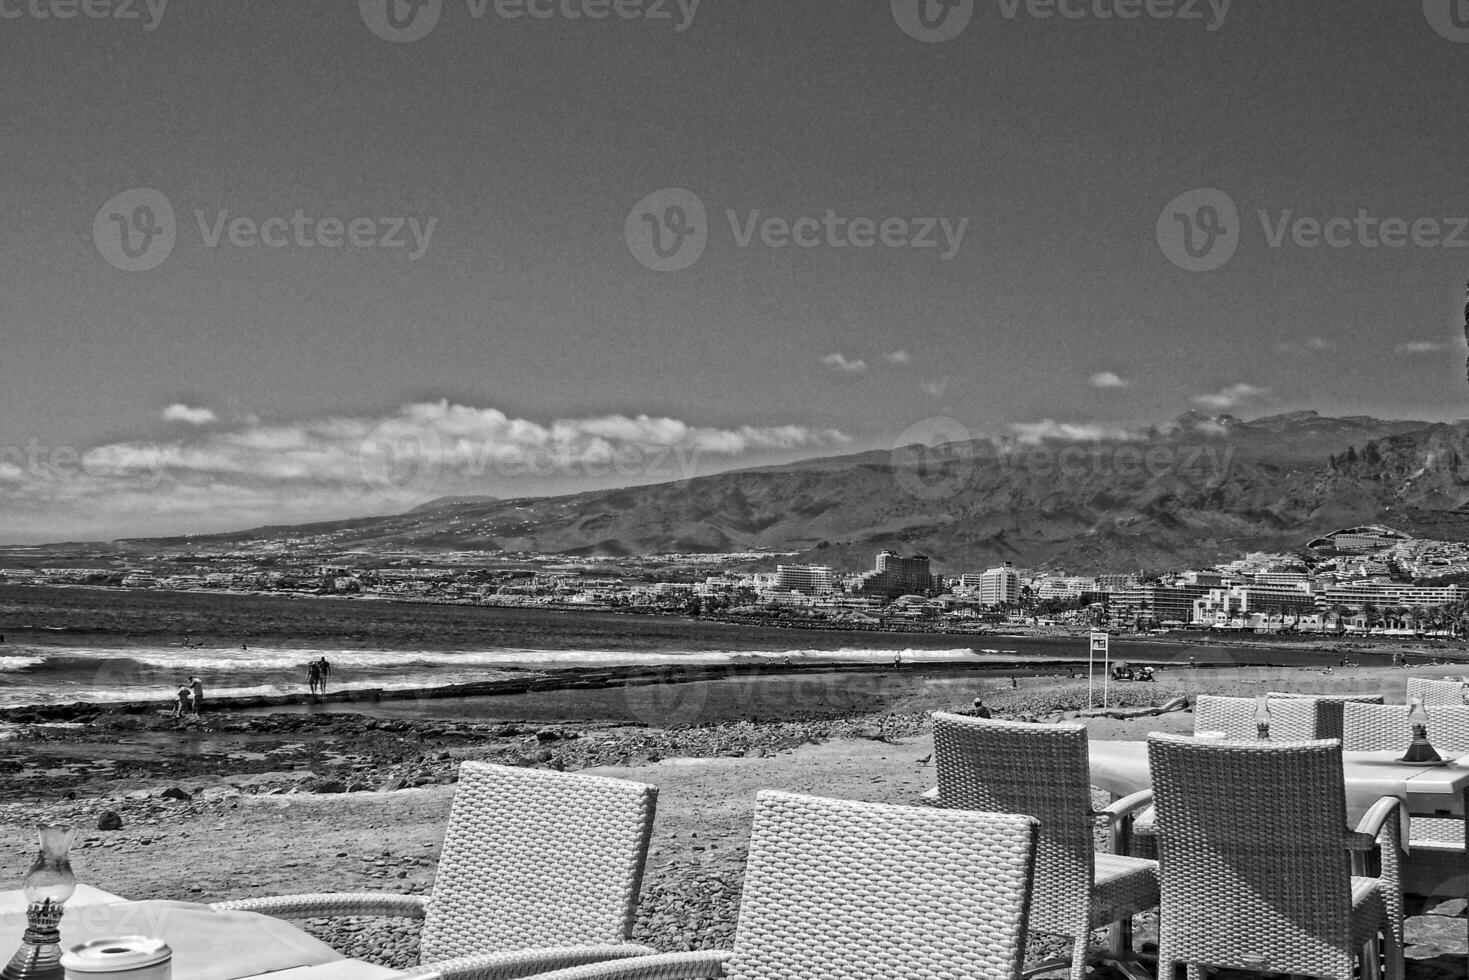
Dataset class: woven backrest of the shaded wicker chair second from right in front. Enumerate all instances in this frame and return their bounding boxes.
[933,711,1096,934]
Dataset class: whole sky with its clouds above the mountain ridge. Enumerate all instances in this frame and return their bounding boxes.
[0,0,1469,542]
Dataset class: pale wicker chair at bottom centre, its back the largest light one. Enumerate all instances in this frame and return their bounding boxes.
[423,790,1036,980]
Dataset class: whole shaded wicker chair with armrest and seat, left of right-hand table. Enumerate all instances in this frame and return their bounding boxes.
[933,713,1158,980]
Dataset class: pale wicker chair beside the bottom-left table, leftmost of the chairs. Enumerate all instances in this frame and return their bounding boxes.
[214,763,658,980]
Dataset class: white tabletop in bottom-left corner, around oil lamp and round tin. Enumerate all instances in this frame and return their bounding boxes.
[0,884,395,980]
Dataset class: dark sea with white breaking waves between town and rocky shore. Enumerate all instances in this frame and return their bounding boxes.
[0,586,1385,707]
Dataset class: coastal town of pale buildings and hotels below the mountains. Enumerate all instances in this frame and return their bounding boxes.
[0,525,1469,636]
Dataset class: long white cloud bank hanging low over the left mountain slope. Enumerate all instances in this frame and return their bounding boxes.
[0,400,851,541]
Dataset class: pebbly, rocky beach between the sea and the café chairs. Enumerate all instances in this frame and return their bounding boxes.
[0,666,1465,980]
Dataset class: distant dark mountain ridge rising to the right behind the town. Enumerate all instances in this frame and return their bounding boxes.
[117,411,1469,572]
